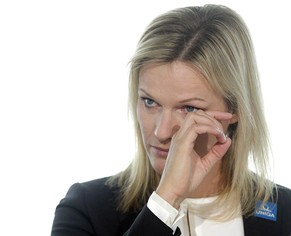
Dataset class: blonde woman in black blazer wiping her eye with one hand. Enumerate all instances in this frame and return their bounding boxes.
[52,5,291,236]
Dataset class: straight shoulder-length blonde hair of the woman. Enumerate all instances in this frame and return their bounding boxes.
[111,5,273,219]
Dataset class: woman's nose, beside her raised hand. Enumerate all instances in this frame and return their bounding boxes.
[154,110,180,143]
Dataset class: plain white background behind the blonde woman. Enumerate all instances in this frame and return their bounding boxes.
[0,0,291,236]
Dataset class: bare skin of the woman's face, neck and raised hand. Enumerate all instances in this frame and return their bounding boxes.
[137,61,236,209]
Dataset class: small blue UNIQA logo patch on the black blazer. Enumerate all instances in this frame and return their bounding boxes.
[255,201,277,221]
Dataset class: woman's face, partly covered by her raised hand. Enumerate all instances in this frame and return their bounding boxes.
[137,62,227,174]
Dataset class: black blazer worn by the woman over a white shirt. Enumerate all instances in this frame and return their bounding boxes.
[51,178,291,236]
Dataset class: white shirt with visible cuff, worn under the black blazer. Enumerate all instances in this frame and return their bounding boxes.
[147,192,244,236]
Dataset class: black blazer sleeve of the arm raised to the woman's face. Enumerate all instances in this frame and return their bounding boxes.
[51,184,180,236]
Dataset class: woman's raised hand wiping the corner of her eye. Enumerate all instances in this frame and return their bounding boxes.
[156,110,232,208]
